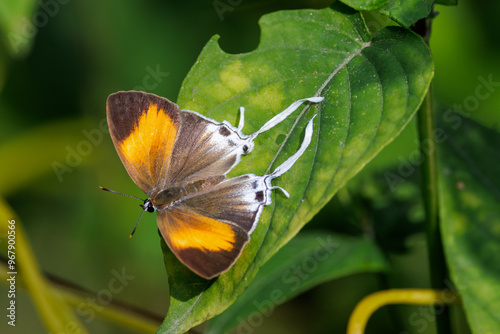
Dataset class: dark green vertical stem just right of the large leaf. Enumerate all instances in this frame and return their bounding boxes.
[418,84,451,334]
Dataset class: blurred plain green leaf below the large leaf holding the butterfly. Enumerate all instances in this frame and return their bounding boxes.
[206,232,386,334]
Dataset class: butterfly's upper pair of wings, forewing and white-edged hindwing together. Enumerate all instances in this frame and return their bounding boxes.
[107,91,253,196]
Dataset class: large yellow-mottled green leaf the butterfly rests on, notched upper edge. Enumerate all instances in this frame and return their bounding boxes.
[159,3,433,333]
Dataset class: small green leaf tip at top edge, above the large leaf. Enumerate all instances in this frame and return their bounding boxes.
[381,0,434,27]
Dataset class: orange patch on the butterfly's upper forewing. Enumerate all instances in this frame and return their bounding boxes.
[120,103,179,184]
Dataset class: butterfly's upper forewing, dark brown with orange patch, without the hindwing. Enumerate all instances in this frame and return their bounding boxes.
[106,92,181,196]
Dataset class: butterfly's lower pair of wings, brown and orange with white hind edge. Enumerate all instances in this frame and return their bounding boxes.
[157,174,271,279]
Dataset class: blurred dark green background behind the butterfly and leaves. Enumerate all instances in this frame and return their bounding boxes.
[0,0,500,334]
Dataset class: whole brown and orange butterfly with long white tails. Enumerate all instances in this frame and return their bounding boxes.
[101,91,323,279]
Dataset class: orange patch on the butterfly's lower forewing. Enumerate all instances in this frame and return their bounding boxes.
[164,210,237,252]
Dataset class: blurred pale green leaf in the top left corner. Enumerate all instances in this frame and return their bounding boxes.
[0,0,39,57]
